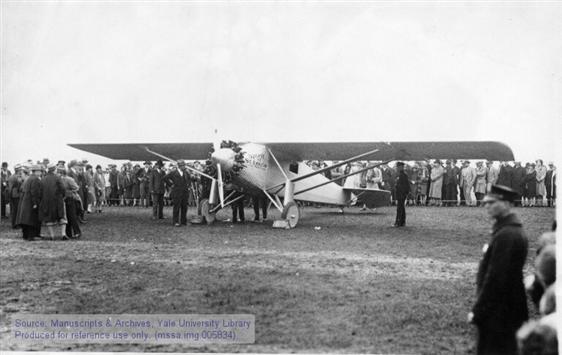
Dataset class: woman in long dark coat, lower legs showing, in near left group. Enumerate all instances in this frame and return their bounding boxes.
[39,164,66,240]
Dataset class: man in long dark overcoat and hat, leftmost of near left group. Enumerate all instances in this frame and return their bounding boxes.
[16,164,43,241]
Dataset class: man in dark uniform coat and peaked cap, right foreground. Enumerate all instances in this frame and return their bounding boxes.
[468,185,529,355]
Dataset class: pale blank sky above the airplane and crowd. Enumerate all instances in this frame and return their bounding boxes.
[1,1,562,166]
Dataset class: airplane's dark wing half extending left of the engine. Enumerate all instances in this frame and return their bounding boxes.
[69,143,213,161]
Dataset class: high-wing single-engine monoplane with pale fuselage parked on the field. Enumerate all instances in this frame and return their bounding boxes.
[68,141,514,229]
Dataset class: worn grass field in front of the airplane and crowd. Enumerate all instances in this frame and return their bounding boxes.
[0,207,555,354]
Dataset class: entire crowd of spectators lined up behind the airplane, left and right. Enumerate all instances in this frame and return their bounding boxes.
[2,159,556,239]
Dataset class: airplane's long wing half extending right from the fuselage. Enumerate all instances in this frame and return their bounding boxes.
[263,141,514,161]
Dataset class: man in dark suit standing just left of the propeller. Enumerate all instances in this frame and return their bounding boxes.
[164,160,191,227]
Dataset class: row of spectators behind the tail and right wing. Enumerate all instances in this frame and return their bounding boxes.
[307,159,556,207]
